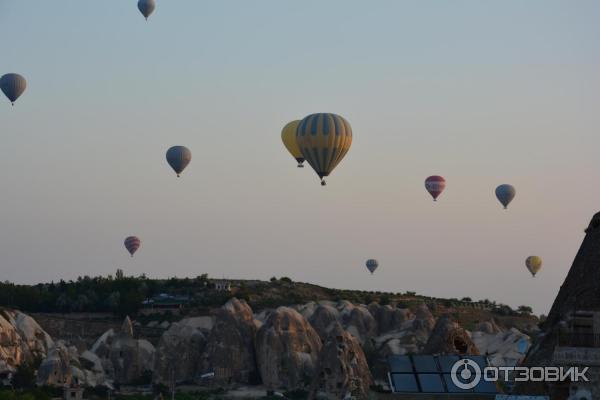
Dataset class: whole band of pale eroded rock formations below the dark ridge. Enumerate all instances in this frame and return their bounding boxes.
[0,298,536,399]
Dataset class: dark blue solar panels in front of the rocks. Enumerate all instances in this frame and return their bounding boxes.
[388,355,498,394]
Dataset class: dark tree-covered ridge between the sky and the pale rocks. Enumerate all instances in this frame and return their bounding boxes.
[0,270,530,324]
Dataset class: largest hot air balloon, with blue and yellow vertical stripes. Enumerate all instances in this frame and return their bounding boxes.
[296,114,352,186]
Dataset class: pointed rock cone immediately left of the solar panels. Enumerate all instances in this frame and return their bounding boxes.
[309,323,373,400]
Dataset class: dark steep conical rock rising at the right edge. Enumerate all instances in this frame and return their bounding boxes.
[515,213,600,399]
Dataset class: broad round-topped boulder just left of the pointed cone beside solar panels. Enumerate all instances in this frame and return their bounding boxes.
[256,307,321,390]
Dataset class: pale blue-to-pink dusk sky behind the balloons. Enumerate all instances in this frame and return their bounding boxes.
[0,0,600,313]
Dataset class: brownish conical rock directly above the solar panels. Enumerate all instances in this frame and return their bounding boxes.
[423,315,479,355]
